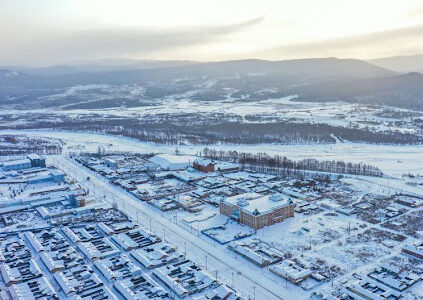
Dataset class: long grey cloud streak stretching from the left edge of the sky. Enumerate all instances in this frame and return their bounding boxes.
[0,17,264,64]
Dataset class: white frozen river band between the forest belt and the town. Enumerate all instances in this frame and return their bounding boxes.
[0,130,423,177]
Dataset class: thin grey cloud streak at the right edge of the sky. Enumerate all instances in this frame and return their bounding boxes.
[261,25,423,57]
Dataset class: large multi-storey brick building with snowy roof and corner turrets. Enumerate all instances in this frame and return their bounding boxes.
[220,193,295,229]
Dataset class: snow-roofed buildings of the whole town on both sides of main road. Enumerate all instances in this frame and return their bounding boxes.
[0,153,423,300]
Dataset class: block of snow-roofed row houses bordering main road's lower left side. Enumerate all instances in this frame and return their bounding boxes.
[58,216,245,299]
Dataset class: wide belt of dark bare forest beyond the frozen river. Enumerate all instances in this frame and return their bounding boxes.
[6,114,423,145]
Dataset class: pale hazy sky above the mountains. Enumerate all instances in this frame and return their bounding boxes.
[0,0,423,65]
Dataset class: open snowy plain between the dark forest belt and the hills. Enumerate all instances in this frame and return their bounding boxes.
[0,92,422,133]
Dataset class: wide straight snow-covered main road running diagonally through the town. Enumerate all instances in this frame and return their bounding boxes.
[48,155,307,300]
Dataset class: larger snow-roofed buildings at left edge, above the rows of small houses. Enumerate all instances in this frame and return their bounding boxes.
[0,155,95,238]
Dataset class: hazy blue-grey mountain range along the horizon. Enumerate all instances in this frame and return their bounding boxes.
[0,56,423,110]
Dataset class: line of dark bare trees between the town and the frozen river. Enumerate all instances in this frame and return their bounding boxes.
[198,148,383,176]
